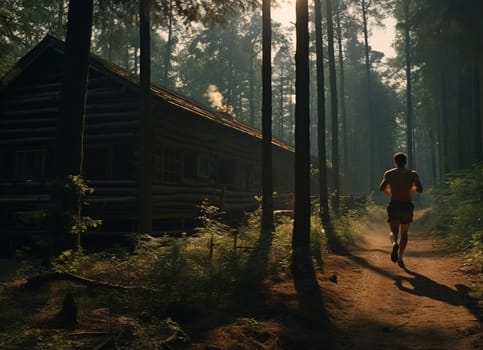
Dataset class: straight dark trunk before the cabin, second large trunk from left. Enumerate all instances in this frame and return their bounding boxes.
[138,0,154,233]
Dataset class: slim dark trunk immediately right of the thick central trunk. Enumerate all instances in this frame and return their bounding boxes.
[314,0,330,227]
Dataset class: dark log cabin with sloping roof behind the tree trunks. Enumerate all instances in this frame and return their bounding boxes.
[0,36,302,246]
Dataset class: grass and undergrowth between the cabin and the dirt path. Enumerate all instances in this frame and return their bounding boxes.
[0,197,372,350]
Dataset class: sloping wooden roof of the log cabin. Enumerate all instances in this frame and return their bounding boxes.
[0,35,294,151]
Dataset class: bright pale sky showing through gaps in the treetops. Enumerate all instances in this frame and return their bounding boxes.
[272,1,396,58]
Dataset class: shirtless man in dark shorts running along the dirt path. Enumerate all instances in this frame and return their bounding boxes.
[379,152,423,268]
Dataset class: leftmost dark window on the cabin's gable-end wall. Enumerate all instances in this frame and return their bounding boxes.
[15,149,46,181]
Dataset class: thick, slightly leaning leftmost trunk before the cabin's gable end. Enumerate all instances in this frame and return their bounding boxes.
[52,0,93,251]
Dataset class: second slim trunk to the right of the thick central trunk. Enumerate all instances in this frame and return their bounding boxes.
[326,0,340,212]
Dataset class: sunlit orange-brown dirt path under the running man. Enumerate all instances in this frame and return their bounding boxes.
[321,215,483,350]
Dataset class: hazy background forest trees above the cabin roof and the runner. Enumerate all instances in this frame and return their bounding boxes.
[0,0,483,193]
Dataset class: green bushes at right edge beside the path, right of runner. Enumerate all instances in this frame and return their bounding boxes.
[429,164,483,262]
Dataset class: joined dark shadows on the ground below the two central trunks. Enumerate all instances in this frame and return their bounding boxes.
[235,231,333,350]
